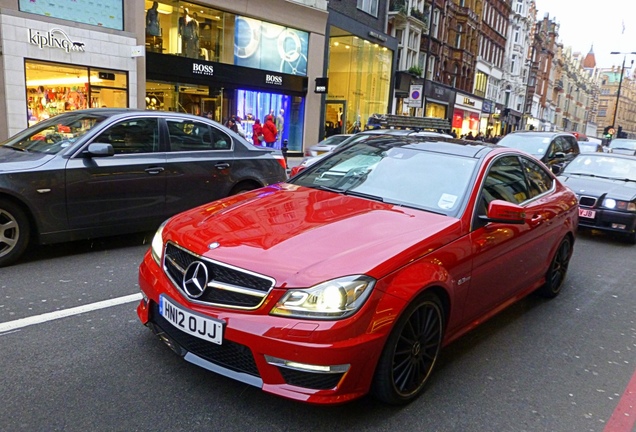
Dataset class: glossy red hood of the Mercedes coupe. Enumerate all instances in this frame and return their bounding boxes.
[164,183,462,287]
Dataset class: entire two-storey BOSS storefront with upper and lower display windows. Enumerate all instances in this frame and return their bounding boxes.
[144,0,327,152]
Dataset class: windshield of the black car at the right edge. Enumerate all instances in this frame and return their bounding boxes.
[562,153,636,181]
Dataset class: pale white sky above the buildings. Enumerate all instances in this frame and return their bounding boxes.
[535,0,636,68]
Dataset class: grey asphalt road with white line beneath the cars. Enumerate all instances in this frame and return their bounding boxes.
[0,228,636,432]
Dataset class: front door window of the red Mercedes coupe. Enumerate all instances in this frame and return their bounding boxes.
[482,156,530,208]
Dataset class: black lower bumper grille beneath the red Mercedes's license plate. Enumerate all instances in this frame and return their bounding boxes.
[150,302,260,378]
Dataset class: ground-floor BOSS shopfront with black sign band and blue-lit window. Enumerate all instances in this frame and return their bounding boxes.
[146,52,308,151]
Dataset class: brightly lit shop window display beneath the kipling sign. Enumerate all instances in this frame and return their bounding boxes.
[25,61,128,126]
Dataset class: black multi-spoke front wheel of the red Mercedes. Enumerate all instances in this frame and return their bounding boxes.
[372,293,444,405]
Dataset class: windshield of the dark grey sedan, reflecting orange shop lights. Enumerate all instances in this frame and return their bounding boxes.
[0,113,106,154]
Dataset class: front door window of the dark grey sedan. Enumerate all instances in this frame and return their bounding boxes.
[94,118,159,154]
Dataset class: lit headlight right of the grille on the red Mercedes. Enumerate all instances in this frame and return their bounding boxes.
[270,275,375,319]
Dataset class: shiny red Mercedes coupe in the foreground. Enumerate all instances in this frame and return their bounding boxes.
[137,134,578,404]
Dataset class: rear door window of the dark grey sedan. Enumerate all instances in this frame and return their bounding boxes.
[166,119,232,151]
